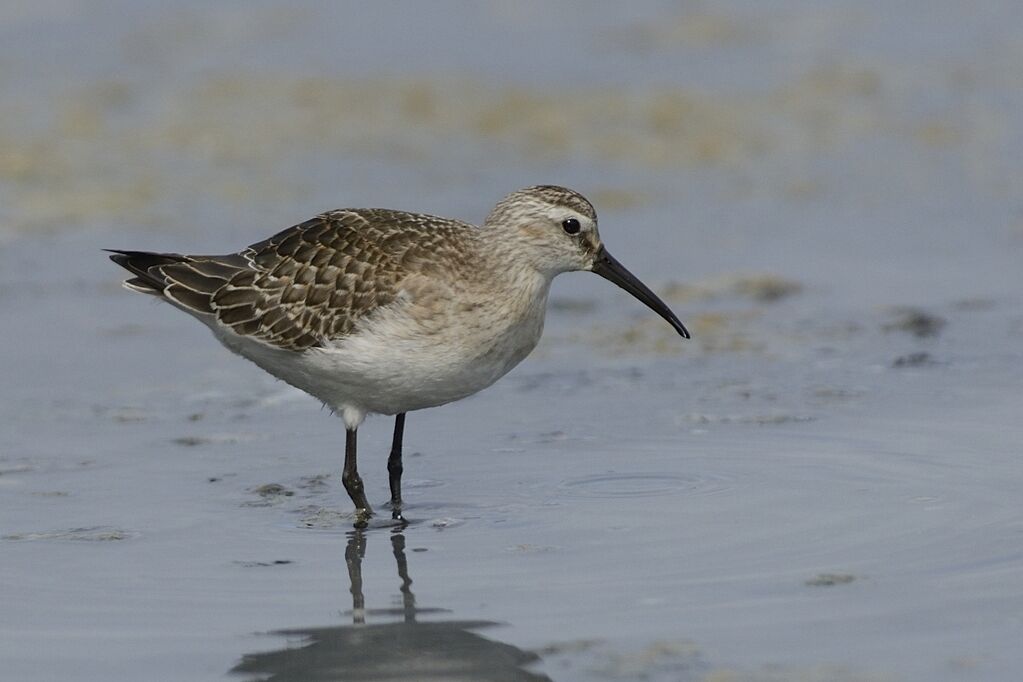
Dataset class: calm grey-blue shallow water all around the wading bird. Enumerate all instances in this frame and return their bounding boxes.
[0,1,1023,682]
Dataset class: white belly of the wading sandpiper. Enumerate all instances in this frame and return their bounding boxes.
[215,274,548,427]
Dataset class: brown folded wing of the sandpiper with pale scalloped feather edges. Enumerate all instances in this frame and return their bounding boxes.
[160,210,468,350]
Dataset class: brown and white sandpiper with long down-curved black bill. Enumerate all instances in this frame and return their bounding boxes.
[110,185,690,527]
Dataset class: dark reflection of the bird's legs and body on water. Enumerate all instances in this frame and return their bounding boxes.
[230,531,551,682]
